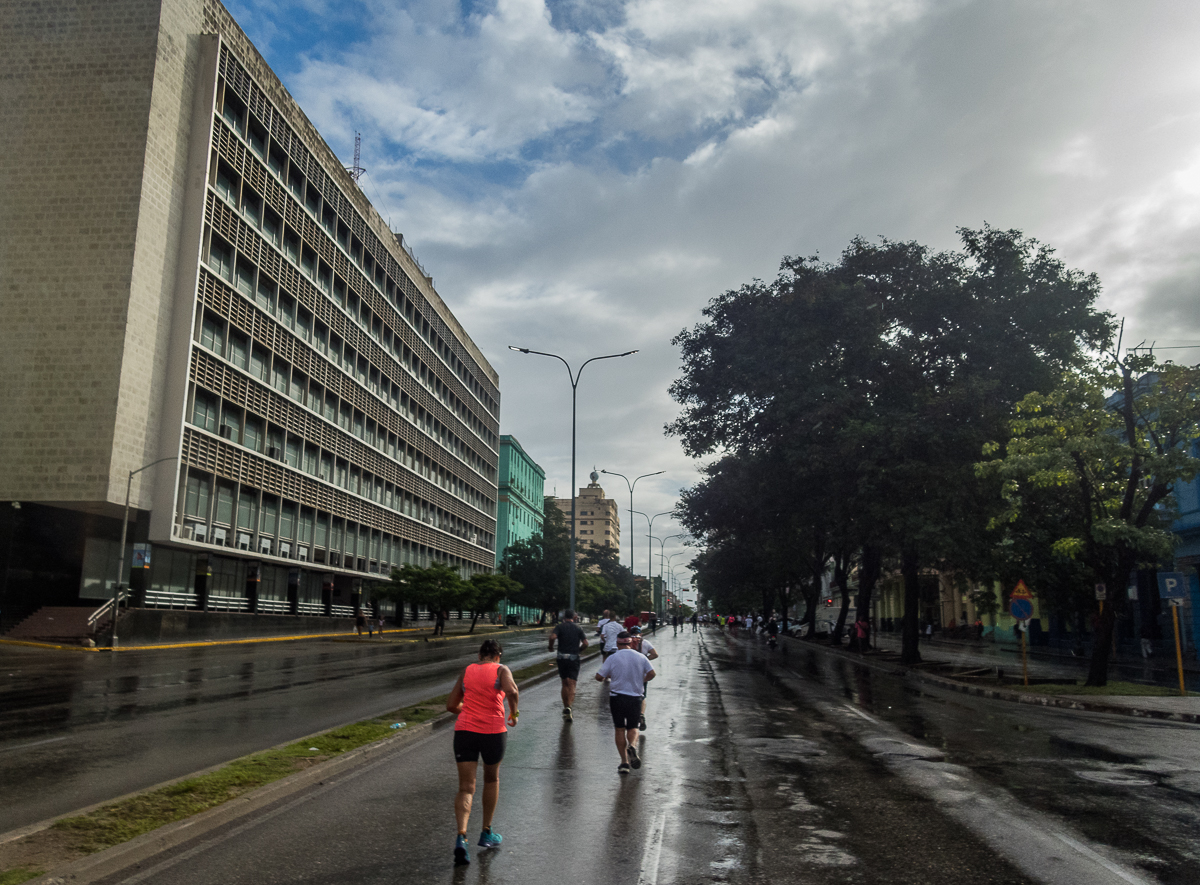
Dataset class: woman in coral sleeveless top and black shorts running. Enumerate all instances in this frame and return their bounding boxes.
[446,639,521,866]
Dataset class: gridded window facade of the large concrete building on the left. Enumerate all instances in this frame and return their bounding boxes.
[174,44,499,574]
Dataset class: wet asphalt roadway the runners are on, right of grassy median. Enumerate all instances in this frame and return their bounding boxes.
[87,632,1200,885]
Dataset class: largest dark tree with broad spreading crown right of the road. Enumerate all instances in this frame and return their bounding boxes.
[668,228,1111,662]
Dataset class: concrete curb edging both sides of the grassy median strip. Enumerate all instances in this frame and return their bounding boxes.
[16,650,599,885]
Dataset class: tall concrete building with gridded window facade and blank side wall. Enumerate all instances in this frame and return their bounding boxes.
[0,0,499,615]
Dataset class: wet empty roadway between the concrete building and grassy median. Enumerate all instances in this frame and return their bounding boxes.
[0,632,548,833]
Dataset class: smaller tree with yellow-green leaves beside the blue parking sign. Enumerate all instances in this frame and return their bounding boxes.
[979,356,1200,686]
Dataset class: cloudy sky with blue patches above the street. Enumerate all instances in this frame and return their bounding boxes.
[227,0,1200,597]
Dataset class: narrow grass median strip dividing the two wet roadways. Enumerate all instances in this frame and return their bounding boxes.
[0,642,590,885]
